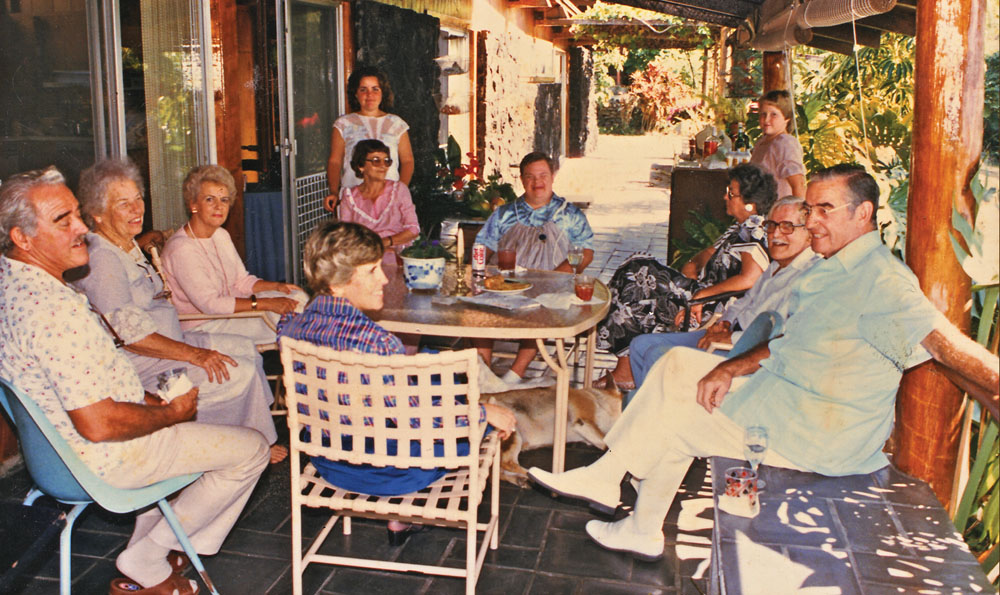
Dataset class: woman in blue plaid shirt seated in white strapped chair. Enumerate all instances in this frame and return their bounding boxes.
[278,221,515,545]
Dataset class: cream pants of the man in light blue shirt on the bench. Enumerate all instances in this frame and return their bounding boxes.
[604,347,798,531]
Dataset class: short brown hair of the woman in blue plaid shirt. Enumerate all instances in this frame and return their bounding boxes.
[302,221,385,294]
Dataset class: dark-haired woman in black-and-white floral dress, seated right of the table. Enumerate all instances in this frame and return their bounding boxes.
[597,163,777,389]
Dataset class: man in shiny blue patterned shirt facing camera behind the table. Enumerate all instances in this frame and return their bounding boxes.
[473,153,594,388]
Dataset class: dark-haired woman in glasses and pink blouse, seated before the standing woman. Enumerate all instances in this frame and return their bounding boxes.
[337,139,420,265]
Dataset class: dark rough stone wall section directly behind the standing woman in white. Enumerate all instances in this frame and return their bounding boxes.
[351,0,441,189]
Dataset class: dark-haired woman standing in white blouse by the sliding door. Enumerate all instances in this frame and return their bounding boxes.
[323,66,413,213]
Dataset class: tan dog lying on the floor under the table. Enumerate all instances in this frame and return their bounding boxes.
[484,387,622,487]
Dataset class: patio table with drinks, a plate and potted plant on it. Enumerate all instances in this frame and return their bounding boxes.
[370,266,610,473]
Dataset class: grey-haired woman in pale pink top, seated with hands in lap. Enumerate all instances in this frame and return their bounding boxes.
[163,165,306,343]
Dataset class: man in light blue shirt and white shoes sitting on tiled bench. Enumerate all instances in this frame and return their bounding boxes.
[528,165,1000,559]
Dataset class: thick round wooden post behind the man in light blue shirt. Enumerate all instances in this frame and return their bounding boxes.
[895,0,986,506]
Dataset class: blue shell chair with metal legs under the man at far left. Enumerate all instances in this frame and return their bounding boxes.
[0,378,219,595]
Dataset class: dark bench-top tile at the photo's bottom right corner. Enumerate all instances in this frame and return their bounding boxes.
[855,554,996,593]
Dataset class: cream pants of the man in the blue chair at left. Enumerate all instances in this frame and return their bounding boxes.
[104,422,270,555]
